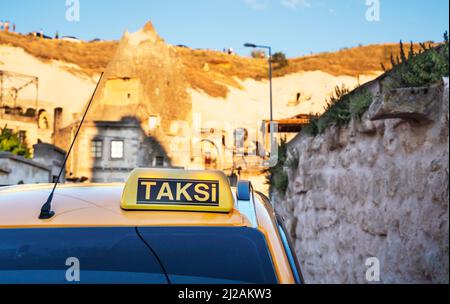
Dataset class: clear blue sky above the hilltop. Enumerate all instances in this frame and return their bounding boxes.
[0,0,449,57]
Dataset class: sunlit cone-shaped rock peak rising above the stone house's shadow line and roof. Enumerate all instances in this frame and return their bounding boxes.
[90,22,192,133]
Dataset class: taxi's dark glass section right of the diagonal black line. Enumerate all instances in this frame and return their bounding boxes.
[139,227,277,284]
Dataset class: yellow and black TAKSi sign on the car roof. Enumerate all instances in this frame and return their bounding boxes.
[121,169,234,213]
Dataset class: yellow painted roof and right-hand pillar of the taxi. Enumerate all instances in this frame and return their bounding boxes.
[0,184,295,284]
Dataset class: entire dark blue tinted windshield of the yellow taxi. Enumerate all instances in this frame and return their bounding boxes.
[0,227,277,284]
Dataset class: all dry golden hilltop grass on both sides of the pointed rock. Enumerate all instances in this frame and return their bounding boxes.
[0,32,426,97]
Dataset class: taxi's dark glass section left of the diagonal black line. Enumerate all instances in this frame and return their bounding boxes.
[0,228,167,284]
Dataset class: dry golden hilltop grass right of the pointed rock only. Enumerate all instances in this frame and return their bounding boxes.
[177,44,419,97]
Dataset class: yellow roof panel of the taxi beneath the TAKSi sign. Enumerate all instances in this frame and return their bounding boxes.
[0,184,250,228]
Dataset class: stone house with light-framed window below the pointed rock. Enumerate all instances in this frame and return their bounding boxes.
[59,118,170,183]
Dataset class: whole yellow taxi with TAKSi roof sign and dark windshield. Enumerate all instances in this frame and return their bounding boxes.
[0,169,302,284]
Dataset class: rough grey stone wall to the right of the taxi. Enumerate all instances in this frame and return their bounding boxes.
[274,78,449,283]
